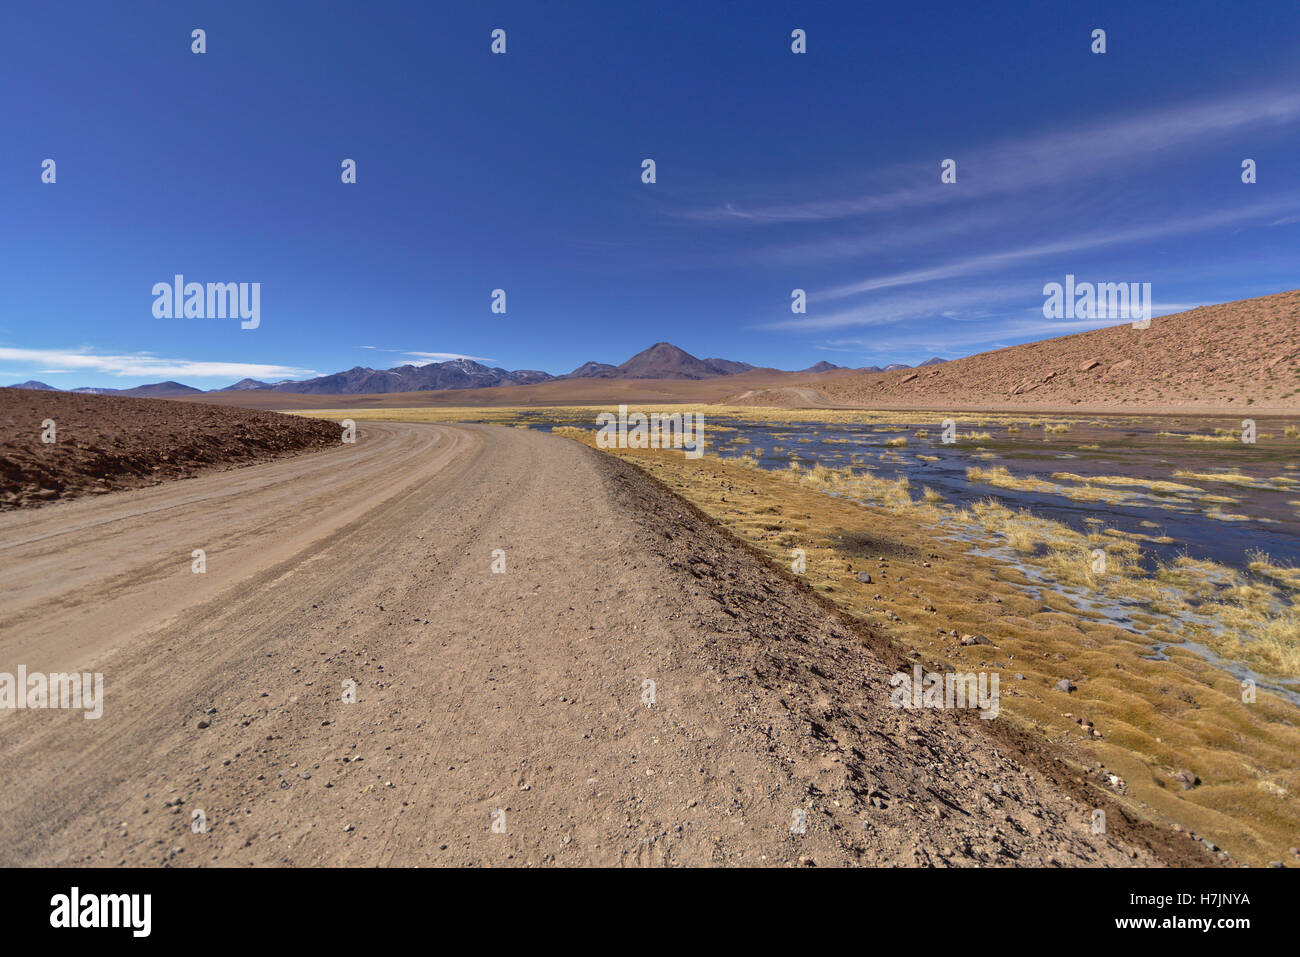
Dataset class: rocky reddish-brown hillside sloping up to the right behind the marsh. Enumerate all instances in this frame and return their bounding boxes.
[806,290,1300,412]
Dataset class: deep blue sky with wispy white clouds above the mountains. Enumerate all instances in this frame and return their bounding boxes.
[0,0,1300,387]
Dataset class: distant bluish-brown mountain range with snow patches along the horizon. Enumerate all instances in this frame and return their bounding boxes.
[9,342,945,398]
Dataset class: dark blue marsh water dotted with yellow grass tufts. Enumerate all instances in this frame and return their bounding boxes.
[530,416,1300,568]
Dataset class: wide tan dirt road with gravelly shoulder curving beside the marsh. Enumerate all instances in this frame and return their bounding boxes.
[0,423,1167,866]
